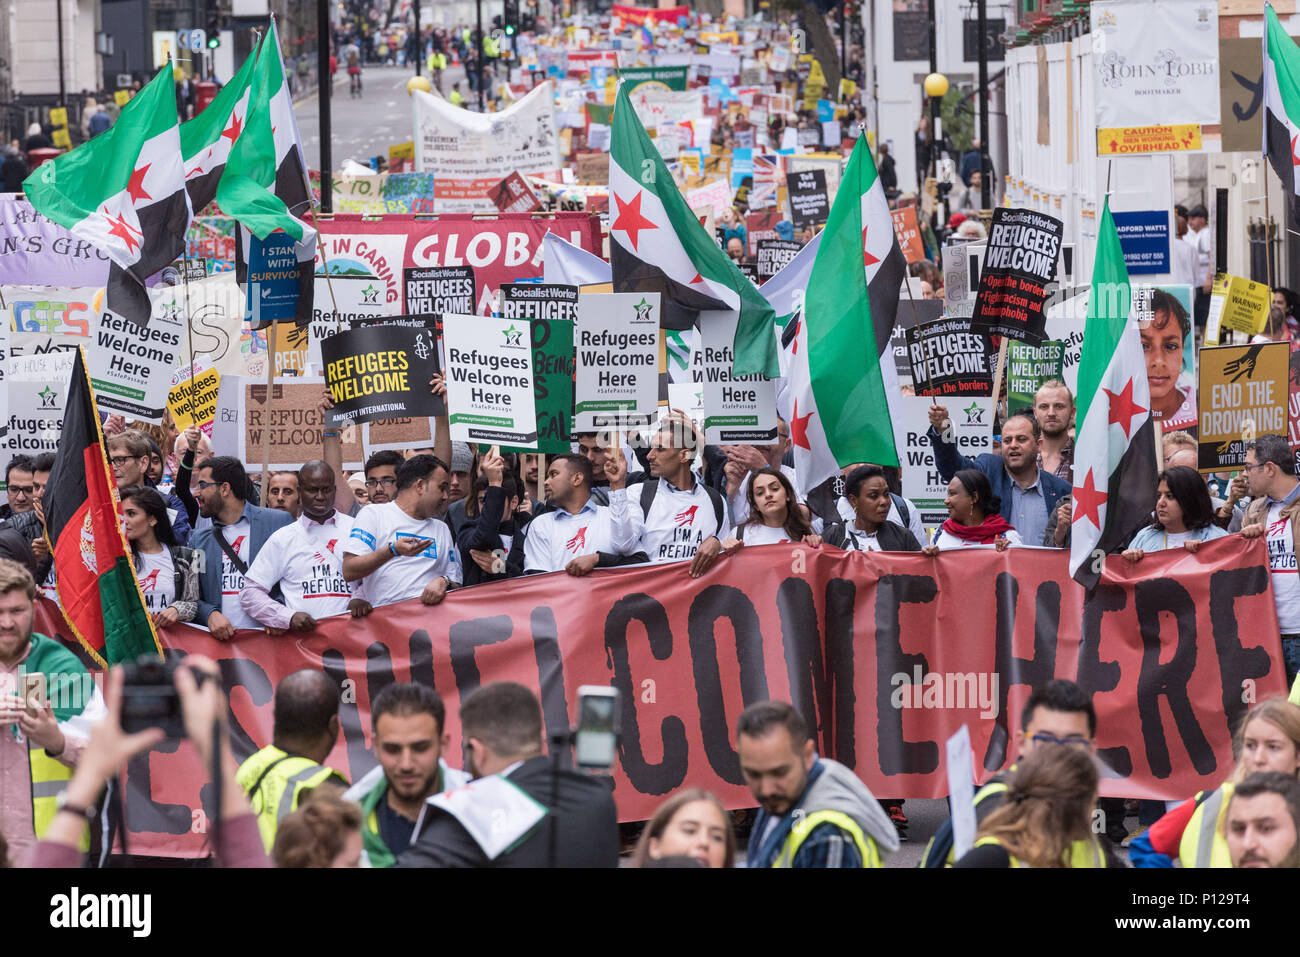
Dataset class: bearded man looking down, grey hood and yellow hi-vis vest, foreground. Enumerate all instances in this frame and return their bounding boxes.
[736,701,898,867]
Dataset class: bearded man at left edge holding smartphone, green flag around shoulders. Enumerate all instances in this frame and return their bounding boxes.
[0,559,107,861]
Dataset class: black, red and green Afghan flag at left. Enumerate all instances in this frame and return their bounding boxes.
[43,348,160,667]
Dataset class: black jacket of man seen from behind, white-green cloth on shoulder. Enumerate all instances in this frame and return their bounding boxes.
[397,755,619,867]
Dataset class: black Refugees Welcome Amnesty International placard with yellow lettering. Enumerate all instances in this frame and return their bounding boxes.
[321,324,446,425]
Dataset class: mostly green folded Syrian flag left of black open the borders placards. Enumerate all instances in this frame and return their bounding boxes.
[774,137,906,489]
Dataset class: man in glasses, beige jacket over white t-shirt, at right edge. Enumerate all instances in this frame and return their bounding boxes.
[1242,436,1300,688]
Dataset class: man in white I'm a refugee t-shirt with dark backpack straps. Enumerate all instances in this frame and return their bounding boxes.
[628,415,731,579]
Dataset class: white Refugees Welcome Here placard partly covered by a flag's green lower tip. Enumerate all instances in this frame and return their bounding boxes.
[699,309,776,445]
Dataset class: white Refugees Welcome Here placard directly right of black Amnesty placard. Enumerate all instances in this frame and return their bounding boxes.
[442,315,537,449]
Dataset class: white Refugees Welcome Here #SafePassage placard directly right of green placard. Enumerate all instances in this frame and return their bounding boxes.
[573,293,662,432]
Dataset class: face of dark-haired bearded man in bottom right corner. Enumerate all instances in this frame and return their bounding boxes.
[1223,771,1300,867]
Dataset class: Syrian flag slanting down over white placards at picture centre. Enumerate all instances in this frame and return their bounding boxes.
[610,85,779,378]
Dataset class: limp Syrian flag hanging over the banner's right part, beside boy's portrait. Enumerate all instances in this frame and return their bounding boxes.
[1070,200,1157,588]
